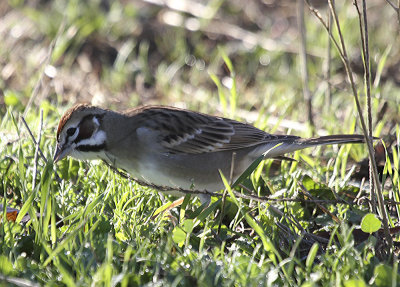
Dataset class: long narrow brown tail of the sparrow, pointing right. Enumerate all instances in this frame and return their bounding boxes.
[253,135,370,158]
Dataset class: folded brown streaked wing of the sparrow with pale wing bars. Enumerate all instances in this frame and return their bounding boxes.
[130,107,298,154]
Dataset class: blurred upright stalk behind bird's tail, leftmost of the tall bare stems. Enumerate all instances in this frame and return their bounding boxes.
[297,0,314,128]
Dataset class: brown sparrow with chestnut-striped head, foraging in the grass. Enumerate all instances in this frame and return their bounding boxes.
[53,104,365,196]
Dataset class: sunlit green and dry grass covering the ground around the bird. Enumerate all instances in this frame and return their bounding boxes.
[0,1,400,286]
